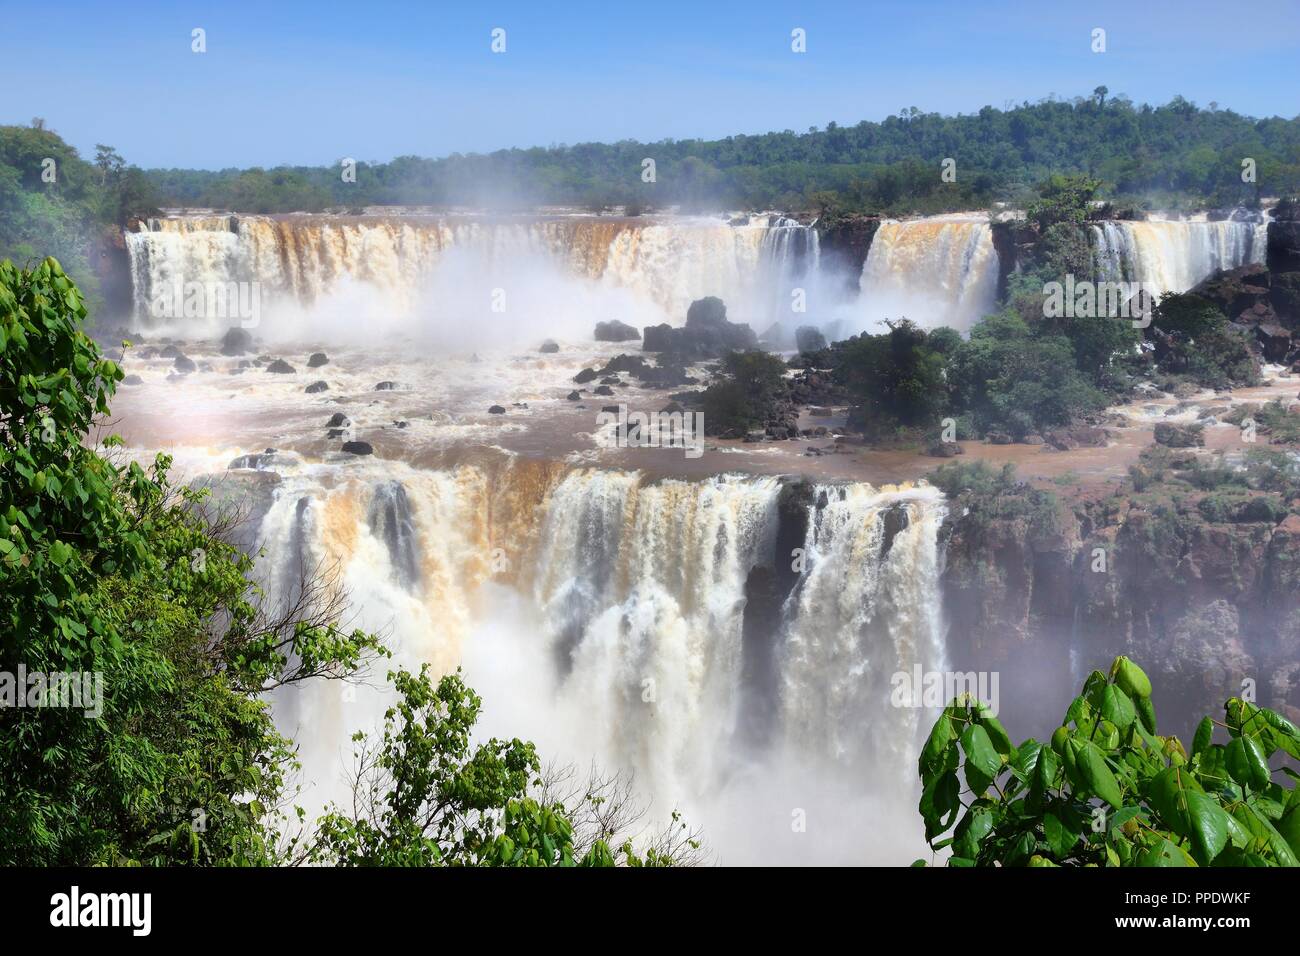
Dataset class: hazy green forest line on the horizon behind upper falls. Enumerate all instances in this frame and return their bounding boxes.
[146,86,1300,215]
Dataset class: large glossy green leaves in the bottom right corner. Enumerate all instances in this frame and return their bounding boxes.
[917,657,1300,866]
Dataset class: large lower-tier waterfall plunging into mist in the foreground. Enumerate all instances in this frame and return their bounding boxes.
[241,462,945,858]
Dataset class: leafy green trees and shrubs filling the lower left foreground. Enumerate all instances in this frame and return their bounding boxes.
[0,259,699,866]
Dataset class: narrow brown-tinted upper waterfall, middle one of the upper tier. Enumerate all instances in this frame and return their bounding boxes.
[858,216,998,332]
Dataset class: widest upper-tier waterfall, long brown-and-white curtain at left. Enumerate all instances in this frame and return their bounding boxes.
[126,216,819,334]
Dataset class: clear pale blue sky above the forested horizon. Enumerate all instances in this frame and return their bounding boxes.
[0,0,1300,169]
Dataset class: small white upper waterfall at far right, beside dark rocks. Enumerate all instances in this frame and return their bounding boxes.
[1091,220,1266,295]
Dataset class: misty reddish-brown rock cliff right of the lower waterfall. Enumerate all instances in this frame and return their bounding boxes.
[941,481,1300,739]
